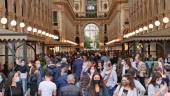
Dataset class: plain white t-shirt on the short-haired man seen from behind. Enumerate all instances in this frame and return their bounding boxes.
[38,81,57,96]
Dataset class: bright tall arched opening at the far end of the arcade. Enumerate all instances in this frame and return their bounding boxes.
[84,24,99,49]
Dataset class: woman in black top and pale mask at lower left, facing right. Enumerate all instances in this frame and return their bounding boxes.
[5,72,24,96]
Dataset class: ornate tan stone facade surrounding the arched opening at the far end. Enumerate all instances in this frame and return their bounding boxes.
[53,0,128,48]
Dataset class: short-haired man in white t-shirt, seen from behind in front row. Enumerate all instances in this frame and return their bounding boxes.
[38,71,57,96]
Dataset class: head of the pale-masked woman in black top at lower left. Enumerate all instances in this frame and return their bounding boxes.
[6,72,20,86]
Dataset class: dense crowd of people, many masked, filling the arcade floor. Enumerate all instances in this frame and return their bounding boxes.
[0,51,170,96]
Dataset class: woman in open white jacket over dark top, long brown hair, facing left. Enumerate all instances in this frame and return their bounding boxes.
[113,74,137,96]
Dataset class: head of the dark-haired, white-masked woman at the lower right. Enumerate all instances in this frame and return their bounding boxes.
[150,72,162,86]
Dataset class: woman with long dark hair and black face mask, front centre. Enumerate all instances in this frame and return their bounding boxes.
[89,72,108,96]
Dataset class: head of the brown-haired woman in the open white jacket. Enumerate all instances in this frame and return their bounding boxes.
[121,74,135,89]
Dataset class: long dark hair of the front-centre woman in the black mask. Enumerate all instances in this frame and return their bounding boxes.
[90,72,105,96]
